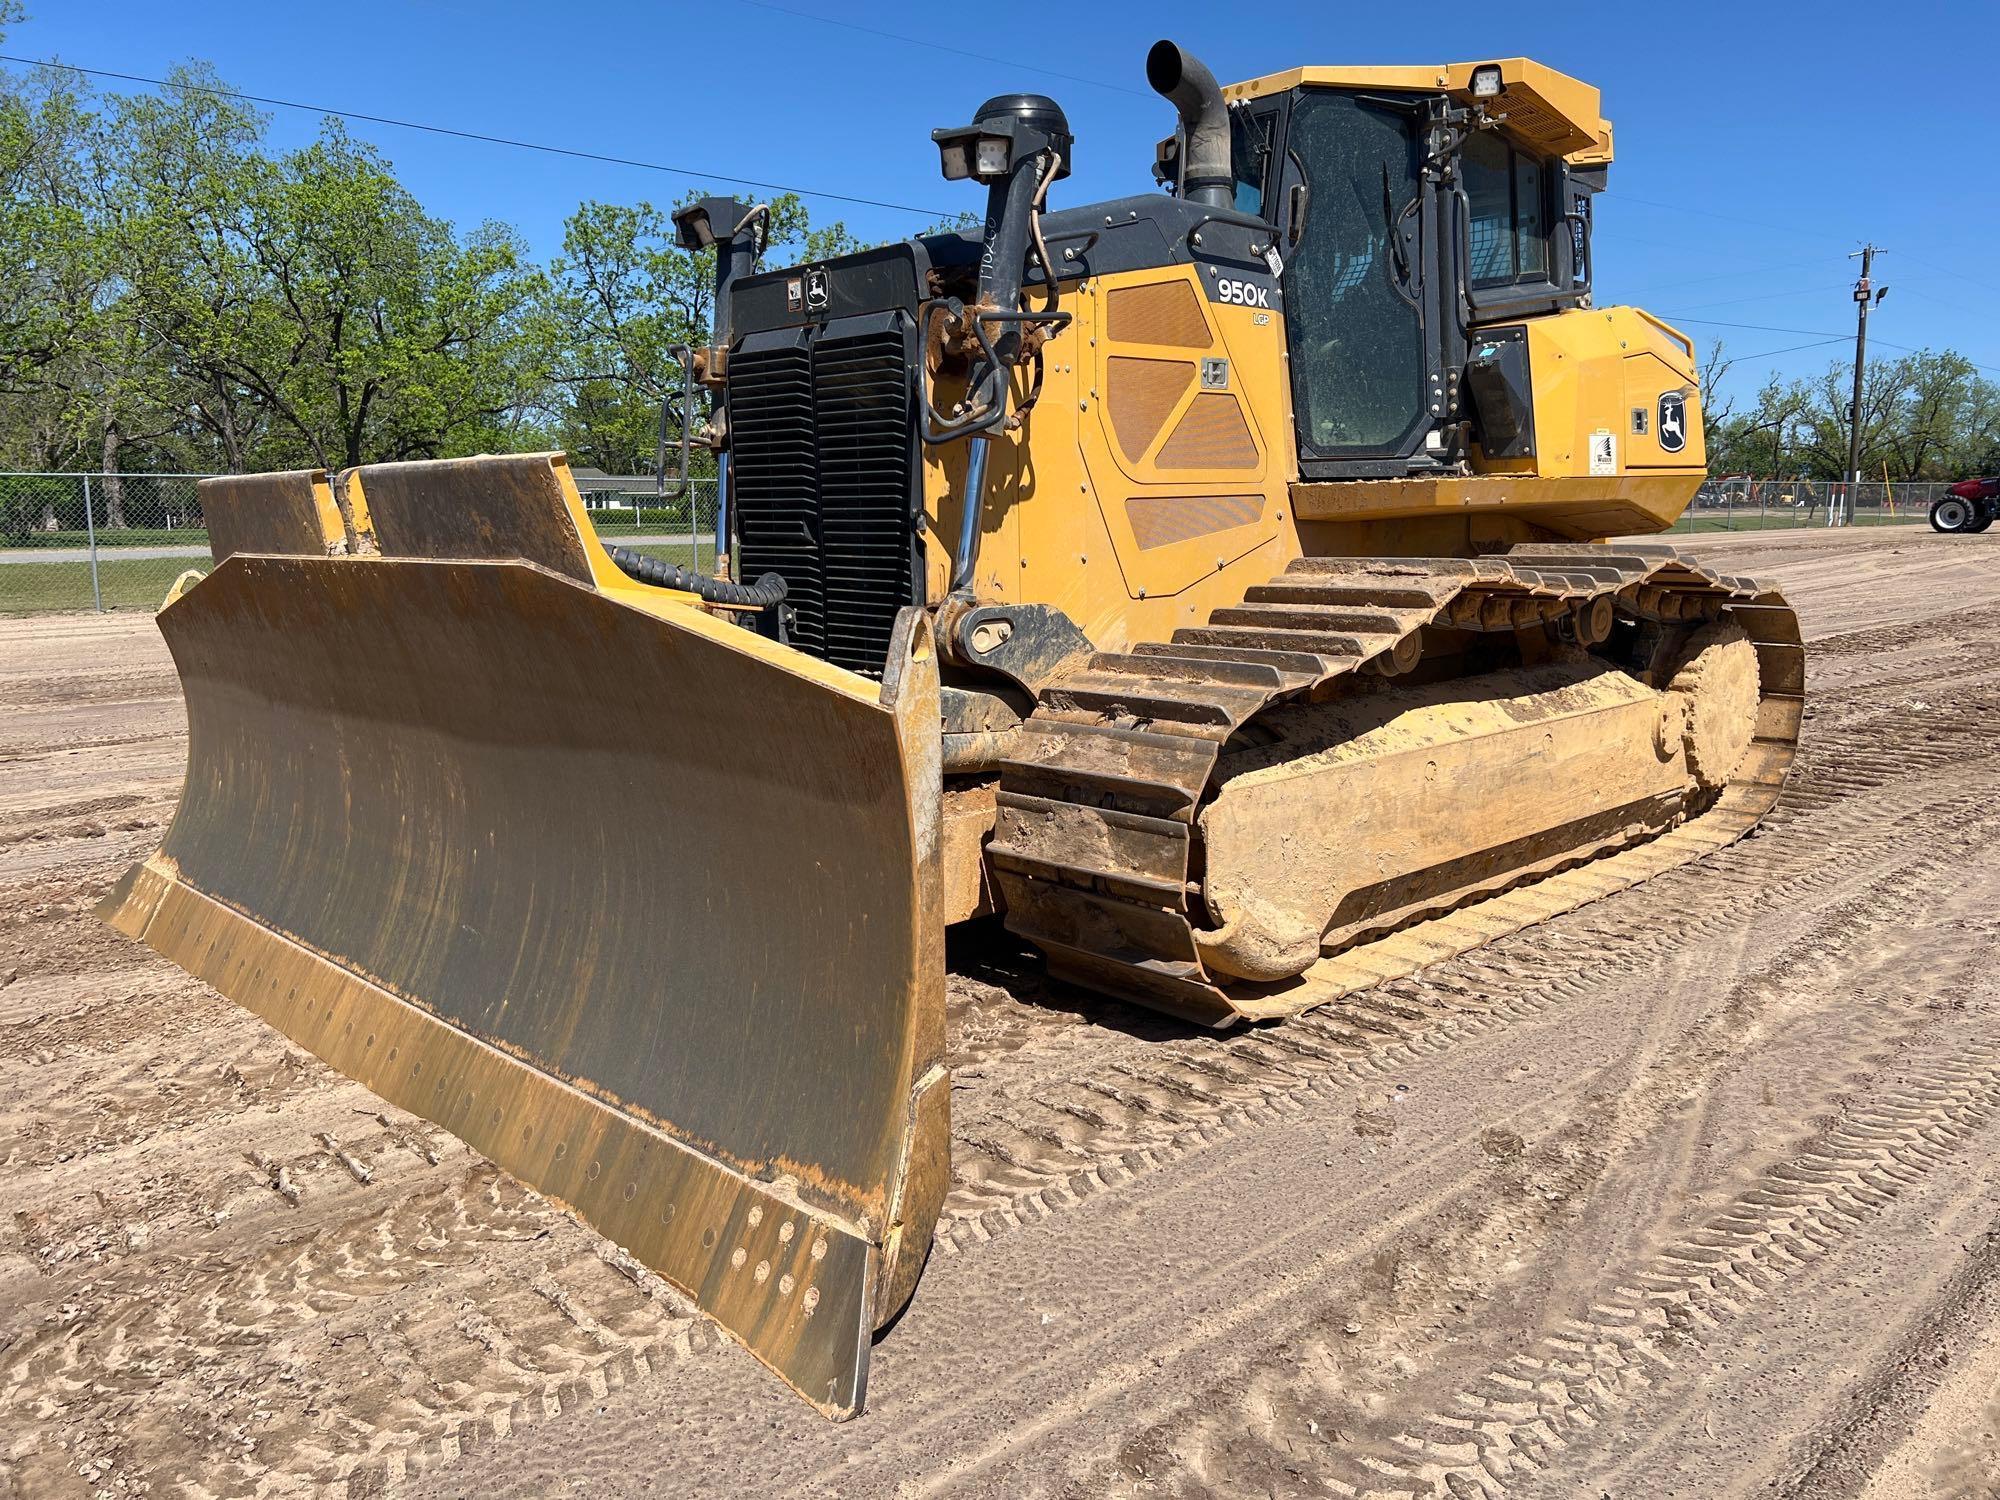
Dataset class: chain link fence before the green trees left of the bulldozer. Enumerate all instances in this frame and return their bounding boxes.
[0,472,716,614]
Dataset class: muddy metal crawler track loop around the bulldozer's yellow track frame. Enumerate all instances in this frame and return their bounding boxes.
[988,544,1804,1026]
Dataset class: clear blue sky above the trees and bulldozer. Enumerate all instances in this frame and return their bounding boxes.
[6,0,2000,412]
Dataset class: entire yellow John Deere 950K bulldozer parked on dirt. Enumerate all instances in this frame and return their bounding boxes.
[102,42,1804,1418]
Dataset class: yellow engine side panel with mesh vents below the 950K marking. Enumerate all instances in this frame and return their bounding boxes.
[924,266,1298,648]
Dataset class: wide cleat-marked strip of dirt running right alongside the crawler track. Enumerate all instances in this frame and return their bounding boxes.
[940,676,2000,1250]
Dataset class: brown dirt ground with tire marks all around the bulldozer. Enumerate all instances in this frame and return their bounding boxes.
[0,528,2000,1500]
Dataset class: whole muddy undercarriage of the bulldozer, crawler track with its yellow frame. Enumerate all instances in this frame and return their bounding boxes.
[988,544,1804,1026]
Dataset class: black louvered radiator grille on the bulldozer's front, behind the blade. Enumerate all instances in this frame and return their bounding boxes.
[730,320,916,674]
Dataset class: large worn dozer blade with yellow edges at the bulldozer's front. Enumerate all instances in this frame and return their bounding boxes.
[100,454,948,1416]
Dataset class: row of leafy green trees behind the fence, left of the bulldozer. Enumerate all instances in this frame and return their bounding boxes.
[0,32,916,488]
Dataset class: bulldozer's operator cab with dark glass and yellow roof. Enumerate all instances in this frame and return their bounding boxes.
[1192,58,1610,480]
